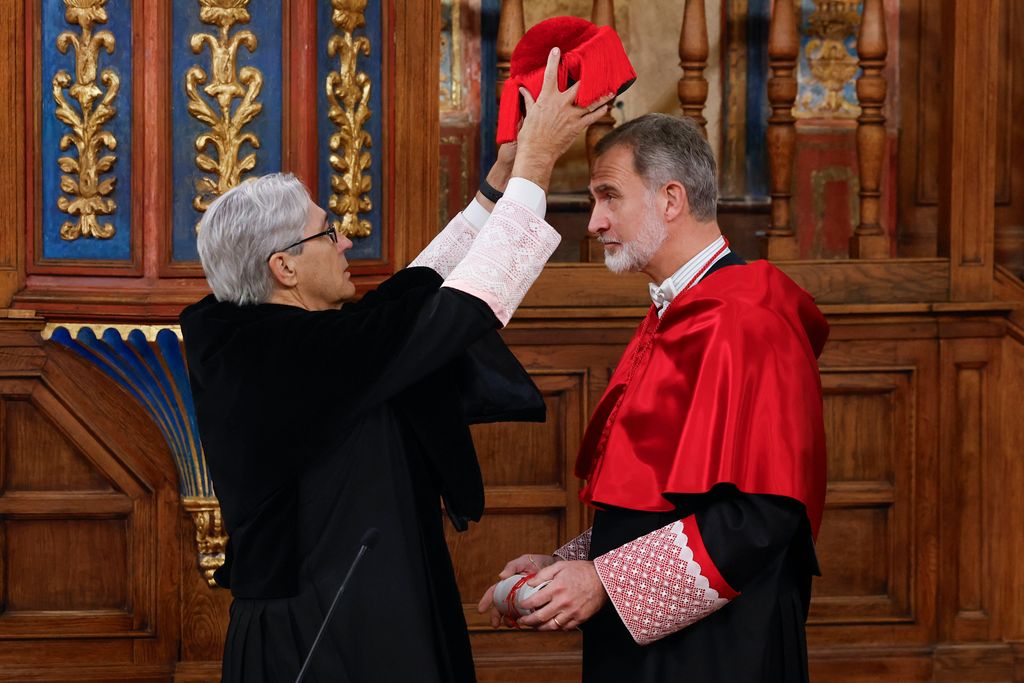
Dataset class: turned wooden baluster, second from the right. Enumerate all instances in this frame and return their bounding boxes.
[763,0,800,259]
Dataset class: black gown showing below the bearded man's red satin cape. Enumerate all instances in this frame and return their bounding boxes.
[582,253,818,683]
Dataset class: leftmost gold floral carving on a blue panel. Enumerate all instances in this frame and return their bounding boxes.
[53,0,121,240]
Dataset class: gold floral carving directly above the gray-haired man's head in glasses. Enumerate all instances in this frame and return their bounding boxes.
[185,0,263,218]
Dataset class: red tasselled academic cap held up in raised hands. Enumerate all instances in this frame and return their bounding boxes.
[498,16,637,144]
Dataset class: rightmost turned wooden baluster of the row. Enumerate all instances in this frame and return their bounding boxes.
[850,0,889,258]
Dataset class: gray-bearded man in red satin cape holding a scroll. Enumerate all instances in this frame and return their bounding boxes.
[479,115,828,683]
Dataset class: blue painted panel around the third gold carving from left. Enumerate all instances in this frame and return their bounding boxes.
[316,1,382,260]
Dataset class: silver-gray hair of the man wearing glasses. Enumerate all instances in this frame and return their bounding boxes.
[197,173,309,306]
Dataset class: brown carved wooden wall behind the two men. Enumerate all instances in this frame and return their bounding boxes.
[0,0,1024,683]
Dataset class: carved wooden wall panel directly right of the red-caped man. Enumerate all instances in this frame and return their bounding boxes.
[808,335,939,651]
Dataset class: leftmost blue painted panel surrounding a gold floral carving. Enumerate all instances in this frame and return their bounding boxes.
[40,0,131,261]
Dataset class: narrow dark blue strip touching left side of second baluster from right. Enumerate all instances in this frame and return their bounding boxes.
[746,0,771,199]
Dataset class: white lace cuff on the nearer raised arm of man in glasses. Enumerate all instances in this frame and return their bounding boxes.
[442,198,561,326]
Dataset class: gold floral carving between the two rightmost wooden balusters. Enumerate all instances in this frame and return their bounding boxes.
[800,0,860,118]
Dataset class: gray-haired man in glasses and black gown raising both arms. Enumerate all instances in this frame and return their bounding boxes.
[181,50,607,683]
